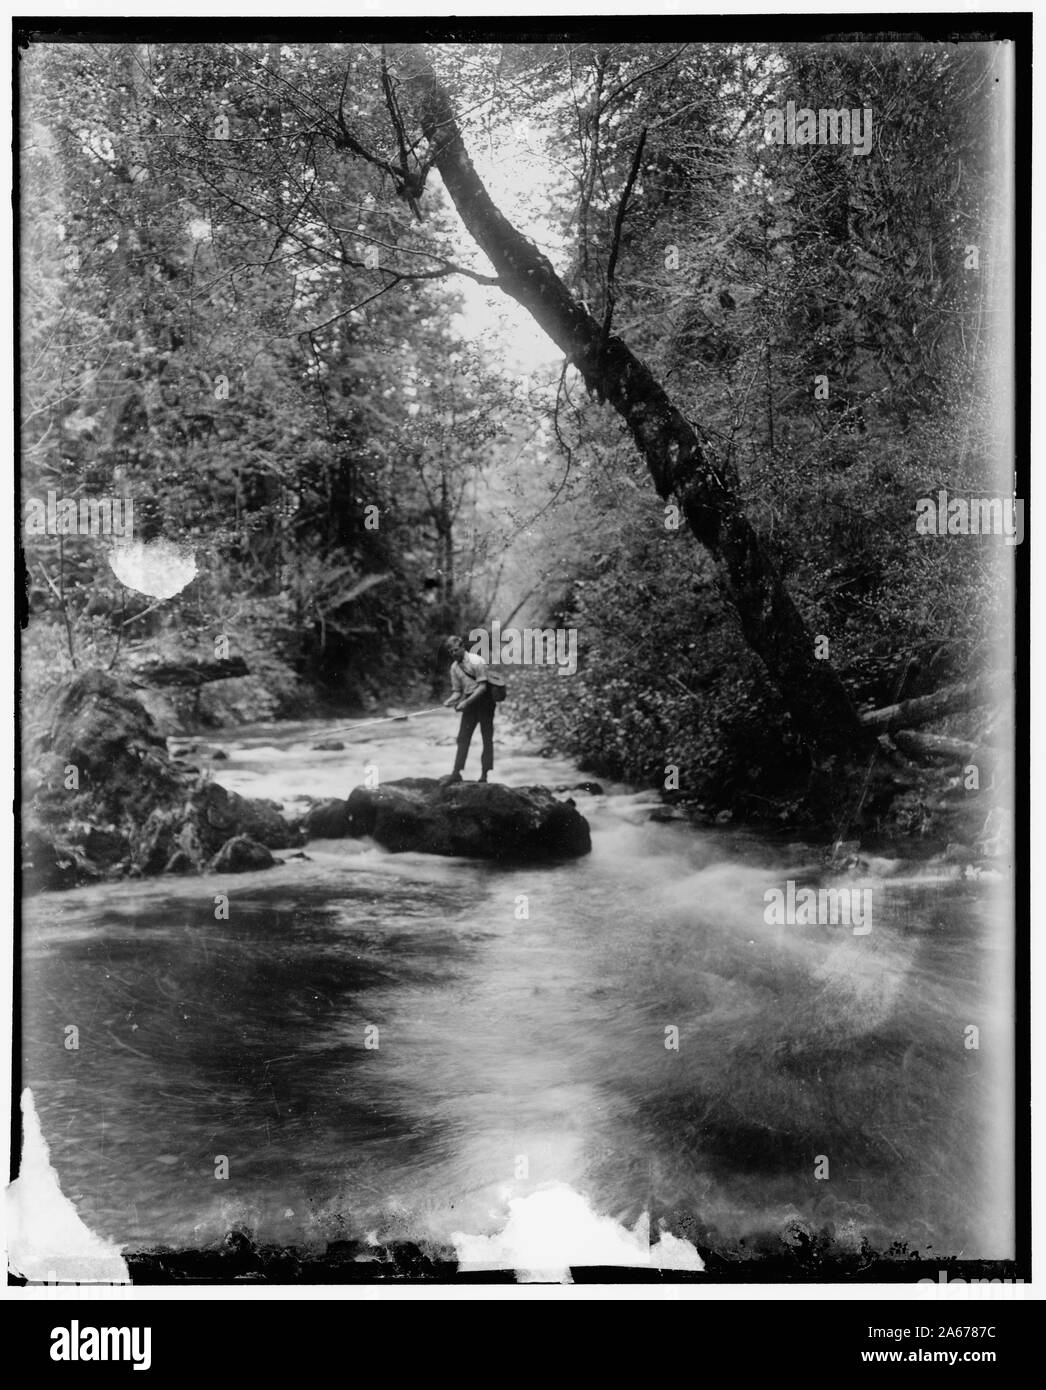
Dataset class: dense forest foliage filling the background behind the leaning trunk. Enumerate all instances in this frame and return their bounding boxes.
[21,42,1013,810]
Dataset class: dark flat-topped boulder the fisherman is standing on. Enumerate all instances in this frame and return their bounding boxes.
[340,777,592,862]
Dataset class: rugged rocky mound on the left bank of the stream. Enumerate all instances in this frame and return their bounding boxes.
[22,670,301,888]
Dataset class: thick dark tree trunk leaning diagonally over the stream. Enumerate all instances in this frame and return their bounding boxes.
[388,44,868,752]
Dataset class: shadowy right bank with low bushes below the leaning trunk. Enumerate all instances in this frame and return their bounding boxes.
[511,653,1014,870]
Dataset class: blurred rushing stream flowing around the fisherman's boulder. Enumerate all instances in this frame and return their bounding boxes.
[22,712,1013,1258]
